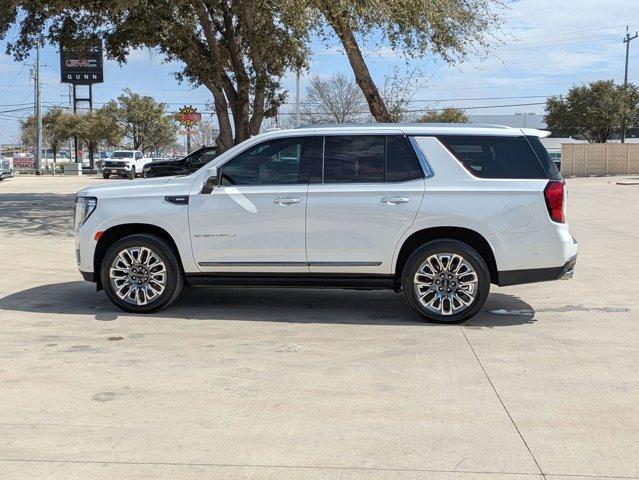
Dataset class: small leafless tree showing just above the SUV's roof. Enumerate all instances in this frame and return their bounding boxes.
[301,73,368,123]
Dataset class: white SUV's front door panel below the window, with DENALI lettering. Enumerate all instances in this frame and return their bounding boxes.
[189,185,308,272]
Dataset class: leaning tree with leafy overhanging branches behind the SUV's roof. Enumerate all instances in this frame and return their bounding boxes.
[307,0,505,122]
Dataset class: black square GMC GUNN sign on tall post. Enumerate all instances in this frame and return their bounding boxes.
[60,39,104,85]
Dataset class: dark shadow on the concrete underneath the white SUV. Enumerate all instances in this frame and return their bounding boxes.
[0,281,535,328]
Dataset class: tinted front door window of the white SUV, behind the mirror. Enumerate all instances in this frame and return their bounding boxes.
[220,138,310,185]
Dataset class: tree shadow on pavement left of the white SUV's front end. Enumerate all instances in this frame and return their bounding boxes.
[0,193,75,236]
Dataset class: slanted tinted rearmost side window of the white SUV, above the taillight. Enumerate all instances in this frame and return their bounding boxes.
[438,135,556,179]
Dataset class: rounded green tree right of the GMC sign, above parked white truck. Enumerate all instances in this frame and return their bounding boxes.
[100,89,177,151]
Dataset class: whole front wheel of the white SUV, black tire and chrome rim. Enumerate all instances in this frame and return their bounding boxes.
[100,234,184,313]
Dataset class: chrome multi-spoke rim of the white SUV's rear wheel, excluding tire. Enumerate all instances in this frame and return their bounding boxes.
[414,253,478,315]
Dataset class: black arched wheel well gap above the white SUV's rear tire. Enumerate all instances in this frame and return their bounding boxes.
[395,227,499,284]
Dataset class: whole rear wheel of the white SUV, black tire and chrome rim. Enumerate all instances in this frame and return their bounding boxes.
[402,239,490,323]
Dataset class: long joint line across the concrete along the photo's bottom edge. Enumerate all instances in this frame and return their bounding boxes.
[0,458,544,478]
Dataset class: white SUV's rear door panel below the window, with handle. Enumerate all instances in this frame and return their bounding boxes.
[306,179,424,274]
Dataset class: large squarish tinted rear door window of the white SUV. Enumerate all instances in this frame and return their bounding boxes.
[324,135,386,183]
